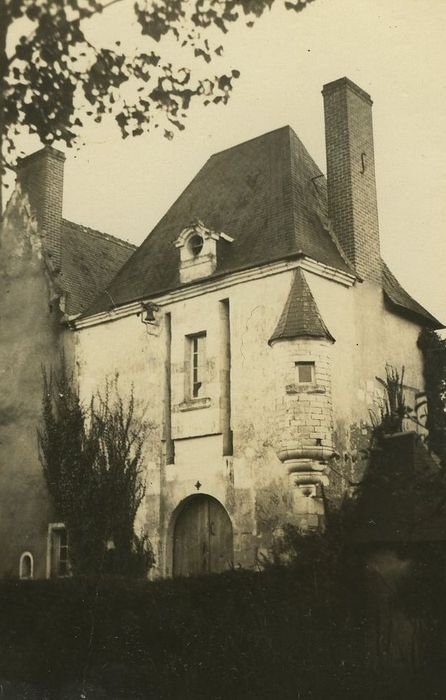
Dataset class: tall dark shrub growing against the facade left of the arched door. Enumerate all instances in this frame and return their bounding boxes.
[38,366,153,576]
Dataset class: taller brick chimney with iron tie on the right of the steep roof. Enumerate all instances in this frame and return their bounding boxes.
[322,78,381,283]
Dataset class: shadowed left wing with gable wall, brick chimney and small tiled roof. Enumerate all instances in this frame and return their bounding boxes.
[0,148,134,578]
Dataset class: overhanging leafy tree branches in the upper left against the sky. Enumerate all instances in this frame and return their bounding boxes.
[0,0,313,212]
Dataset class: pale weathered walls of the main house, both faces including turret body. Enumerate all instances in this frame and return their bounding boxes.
[76,262,422,574]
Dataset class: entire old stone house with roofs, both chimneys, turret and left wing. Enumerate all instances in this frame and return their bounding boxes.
[0,78,441,576]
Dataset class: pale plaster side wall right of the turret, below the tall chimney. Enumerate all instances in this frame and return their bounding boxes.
[307,275,424,495]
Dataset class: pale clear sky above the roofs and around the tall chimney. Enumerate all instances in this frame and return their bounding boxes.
[17,0,446,323]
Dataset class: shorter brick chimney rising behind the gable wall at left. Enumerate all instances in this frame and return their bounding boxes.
[17,146,65,271]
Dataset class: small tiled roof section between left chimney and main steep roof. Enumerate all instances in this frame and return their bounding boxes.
[61,219,135,316]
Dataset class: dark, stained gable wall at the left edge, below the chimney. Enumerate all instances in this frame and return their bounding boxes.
[0,190,70,577]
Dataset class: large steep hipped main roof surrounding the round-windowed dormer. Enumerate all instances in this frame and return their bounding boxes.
[85,126,352,315]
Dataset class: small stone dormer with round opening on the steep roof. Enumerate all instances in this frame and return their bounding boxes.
[175,219,234,284]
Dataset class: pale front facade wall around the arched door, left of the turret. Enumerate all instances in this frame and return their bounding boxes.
[76,275,291,573]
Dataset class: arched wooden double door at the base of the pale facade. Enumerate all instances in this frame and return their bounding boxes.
[172,494,233,576]
